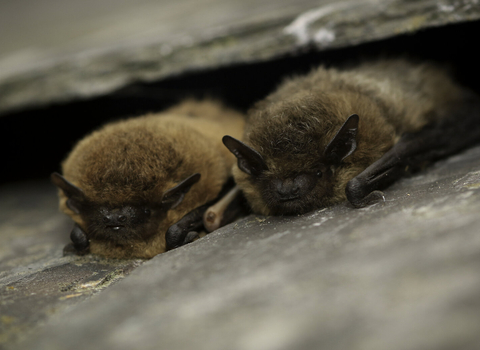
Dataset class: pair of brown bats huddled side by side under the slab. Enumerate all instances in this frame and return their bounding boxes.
[52,59,480,258]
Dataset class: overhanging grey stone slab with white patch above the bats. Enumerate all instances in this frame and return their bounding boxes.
[0,0,480,113]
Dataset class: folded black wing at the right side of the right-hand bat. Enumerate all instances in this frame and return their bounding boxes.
[345,94,480,208]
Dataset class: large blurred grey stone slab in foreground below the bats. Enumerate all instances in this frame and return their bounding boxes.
[5,147,480,350]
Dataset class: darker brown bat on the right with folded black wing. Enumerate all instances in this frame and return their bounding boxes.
[223,59,480,215]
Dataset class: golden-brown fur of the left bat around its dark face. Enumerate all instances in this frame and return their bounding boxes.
[55,101,244,258]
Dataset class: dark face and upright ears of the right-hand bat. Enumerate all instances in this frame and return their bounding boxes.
[223,114,359,215]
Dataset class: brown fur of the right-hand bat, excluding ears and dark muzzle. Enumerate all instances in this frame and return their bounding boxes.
[233,60,462,215]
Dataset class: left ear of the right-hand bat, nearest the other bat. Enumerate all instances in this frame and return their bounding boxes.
[222,135,268,176]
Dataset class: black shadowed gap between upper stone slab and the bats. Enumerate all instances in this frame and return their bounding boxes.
[0,21,480,183]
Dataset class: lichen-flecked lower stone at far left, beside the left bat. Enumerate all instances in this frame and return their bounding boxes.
[0,182,143,349]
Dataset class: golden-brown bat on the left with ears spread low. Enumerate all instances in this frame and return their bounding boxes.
[51,101,245,258]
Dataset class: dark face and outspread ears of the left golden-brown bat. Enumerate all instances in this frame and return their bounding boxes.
[51,173,200,245]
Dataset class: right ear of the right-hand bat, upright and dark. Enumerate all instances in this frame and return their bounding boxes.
[324,114,359,164]
